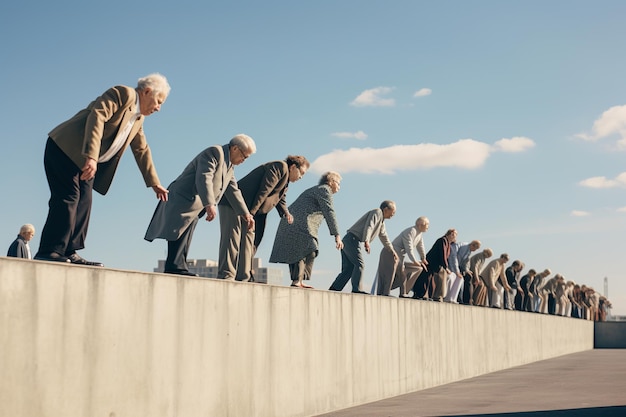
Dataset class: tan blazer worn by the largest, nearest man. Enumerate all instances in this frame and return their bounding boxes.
[48,86,160,195]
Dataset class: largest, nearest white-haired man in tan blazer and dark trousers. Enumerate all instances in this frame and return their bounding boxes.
[35,74,170,266]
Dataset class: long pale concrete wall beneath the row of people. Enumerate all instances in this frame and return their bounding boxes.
[0,258,593,417]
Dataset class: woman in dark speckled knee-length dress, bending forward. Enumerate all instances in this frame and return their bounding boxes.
[270,171,343,288]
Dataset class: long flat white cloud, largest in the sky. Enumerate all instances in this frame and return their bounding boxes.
[311,139,491,174]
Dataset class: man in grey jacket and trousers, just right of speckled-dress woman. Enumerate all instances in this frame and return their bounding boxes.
[329,200,398,294]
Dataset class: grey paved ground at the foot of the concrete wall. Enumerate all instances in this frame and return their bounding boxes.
[316,349,626,417]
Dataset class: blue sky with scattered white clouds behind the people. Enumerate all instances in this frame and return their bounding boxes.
[0,0,626,314]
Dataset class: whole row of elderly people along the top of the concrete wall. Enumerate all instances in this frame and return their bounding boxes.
[9,74,608,320]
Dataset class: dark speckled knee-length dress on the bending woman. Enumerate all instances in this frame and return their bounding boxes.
[270,184,339,264]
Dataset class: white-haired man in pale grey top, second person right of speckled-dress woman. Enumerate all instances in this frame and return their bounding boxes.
[376,216,430,298]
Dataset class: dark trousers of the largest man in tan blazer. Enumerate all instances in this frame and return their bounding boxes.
[37,138,93,256]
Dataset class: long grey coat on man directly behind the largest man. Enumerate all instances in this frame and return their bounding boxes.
[144,145,249,242]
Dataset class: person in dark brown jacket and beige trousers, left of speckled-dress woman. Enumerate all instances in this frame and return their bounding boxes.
[217,155,310,281]
